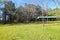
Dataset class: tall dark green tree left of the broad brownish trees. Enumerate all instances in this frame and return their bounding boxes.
[3,1,15,23]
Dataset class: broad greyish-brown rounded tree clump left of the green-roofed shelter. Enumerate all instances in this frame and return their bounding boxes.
[16,4,42,22]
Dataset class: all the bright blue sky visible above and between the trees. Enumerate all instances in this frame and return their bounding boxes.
[0,0,60,16]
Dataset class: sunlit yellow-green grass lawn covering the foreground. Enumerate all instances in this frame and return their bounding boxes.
[0,22,60,40]
